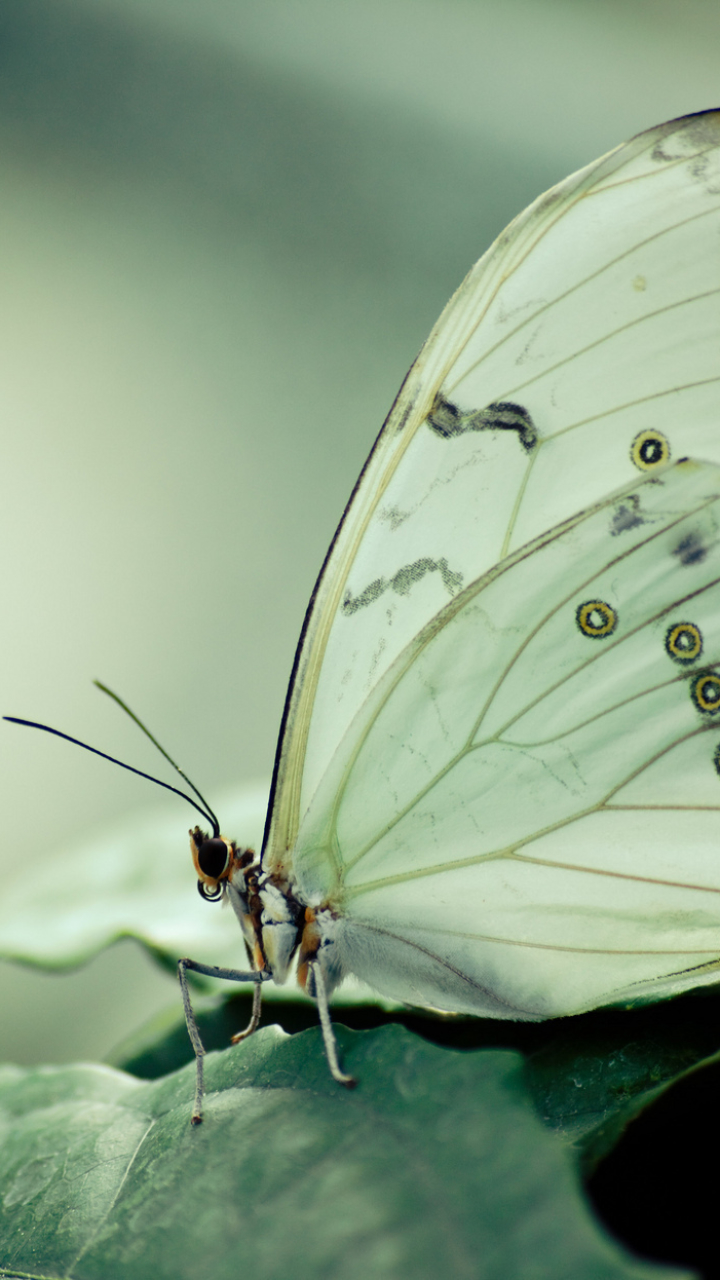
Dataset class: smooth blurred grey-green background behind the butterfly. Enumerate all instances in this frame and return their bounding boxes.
[0,0,720,1062]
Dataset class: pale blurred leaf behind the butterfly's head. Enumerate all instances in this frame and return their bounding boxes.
[0,783,384,1009]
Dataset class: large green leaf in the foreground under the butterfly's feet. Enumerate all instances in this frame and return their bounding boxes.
[0,1027,684,1280]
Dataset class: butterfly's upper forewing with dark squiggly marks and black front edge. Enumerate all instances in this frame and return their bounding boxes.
[264,113,720,870]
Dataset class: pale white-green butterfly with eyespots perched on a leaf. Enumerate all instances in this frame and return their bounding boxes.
[5,111,720,1121]
